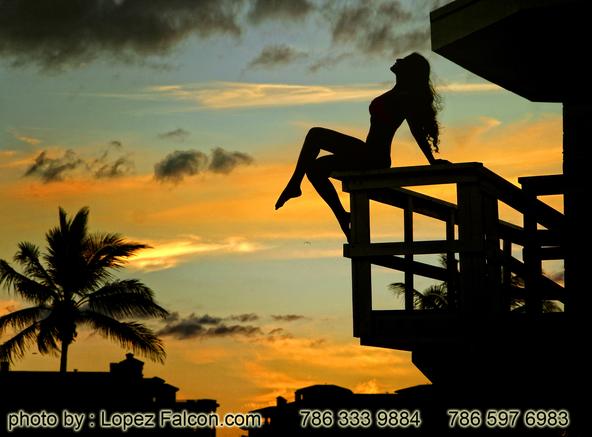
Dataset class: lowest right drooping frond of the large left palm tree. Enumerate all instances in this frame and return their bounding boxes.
[78,311,166,363]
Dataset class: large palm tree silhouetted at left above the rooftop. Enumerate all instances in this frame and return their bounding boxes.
[0,208,168,372]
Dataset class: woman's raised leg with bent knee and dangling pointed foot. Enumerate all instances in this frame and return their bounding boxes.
[275,127,359,209]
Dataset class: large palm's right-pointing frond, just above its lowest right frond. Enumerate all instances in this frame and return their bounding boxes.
[86,279,169,319]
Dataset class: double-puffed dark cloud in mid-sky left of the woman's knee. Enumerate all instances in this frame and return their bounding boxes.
[154,147,254,183]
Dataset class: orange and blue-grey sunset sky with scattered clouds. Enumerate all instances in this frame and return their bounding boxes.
[0,0,562,434]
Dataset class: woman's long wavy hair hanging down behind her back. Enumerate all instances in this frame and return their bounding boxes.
[397,53,441,152]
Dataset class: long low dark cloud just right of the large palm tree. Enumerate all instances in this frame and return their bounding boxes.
[157,313,263,340]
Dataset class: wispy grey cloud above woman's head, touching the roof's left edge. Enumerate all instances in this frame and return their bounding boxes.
[325,1,430,56]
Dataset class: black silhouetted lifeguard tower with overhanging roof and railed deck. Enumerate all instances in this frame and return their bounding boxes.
[337,0,592,407]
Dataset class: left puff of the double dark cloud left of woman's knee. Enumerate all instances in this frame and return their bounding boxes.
[154,150,208,183]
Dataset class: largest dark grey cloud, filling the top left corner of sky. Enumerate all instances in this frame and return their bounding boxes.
[0,0,243,70]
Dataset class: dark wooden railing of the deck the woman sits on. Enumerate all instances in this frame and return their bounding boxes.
[333,163,564,337]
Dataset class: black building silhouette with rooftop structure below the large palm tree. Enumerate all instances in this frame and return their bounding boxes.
[0,353,218,436]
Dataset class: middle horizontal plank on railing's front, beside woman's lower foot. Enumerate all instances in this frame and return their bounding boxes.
[344,240,483,258]
